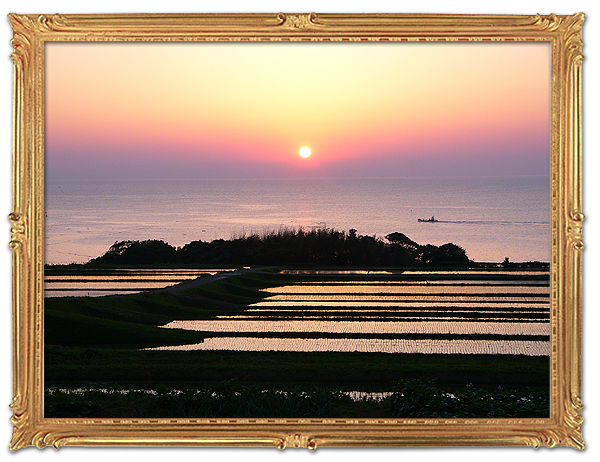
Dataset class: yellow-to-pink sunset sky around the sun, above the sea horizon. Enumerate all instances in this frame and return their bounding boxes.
[45,42,551,180]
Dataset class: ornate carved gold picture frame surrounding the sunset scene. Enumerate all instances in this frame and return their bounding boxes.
[9,13,584,449]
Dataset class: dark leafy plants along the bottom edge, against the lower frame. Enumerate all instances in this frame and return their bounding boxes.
[45,378,549,419]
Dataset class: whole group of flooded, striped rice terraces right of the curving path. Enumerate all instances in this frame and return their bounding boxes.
[160,270,550,356]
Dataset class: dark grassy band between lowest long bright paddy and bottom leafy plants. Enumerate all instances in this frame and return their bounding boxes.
[44,346,549,390]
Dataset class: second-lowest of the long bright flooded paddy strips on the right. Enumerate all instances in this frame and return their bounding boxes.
[162,322,550,335]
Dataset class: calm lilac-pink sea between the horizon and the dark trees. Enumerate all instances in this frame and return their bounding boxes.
[45,177,550,264]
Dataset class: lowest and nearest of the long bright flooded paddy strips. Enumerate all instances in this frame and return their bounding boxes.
[149,337,550,356]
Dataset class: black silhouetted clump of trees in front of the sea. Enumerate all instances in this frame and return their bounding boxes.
[87,228,472,267]
